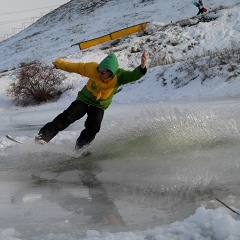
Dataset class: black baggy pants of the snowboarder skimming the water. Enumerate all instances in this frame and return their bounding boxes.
[39,100,104,150]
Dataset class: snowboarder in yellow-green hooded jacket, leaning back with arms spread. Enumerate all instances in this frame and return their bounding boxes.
[35,51,147,151]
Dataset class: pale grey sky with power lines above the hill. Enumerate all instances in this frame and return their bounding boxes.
[0,0,69,41]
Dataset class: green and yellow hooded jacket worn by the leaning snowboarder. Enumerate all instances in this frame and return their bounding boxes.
[54,53,147,110]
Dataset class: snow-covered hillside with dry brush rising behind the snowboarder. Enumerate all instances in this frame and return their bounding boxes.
[0,0,240,108]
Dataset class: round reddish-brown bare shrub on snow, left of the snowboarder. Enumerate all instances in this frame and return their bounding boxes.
[7,61,71,106]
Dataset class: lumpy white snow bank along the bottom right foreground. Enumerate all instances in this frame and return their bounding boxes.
[85,207,240,240]
